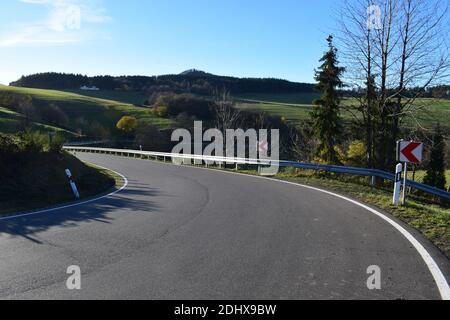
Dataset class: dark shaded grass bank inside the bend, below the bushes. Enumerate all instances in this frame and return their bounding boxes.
[0,153,119,216]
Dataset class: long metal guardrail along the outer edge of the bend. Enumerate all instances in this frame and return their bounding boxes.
[63,146,450,199]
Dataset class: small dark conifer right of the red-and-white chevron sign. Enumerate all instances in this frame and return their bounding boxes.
[423,124,446,190]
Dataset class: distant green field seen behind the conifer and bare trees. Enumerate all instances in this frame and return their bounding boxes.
[234,93,450,130]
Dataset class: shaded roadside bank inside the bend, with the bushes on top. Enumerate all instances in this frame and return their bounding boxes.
[0,134,116,216]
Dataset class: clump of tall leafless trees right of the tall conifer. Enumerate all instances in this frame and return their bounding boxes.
[336,0,450,169]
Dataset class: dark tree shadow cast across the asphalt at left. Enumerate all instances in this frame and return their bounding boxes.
[0,181,160,244]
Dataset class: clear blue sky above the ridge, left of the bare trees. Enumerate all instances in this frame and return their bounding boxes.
[0,0,336,84]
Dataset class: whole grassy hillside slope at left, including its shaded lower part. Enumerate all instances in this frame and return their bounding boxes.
[0,85,170,138]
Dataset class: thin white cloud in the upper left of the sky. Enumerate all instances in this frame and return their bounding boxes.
[0,0,111,47]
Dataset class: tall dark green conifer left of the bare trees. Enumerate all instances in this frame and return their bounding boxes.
[311,36,344,164]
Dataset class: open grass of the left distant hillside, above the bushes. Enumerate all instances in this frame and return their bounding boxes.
[0,85,171,137]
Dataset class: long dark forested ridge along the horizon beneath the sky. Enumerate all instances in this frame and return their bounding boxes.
[10,70,314,95]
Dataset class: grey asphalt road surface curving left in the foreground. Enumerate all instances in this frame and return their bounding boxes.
[0,154,450,299]
